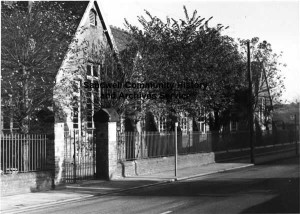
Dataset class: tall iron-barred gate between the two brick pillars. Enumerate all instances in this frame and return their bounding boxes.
[64,130,96,183]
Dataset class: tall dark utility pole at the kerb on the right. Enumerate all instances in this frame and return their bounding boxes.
[247,41,255,164]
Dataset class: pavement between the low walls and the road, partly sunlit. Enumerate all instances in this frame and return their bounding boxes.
[0,162,253,213]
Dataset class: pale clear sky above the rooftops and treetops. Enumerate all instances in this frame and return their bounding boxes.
[100,0,300,102]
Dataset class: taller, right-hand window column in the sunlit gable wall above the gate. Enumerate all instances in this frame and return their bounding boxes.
[86,64,100,129]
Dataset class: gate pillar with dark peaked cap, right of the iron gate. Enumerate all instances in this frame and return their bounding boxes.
[94,108,120,180]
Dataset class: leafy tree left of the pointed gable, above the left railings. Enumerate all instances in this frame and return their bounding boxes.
[1,1,81,133]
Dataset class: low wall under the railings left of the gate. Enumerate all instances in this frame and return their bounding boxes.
[1,171,53,196]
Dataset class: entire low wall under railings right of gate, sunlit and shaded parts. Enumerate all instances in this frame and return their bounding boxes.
[112,144,300,179]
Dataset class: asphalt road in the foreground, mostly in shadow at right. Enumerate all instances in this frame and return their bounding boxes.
[29,158,299,214]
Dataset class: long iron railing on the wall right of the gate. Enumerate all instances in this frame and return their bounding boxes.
[118,130,299,161]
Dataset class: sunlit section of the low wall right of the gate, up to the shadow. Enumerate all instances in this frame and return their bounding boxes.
[113,153,215,178]
